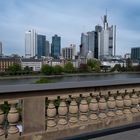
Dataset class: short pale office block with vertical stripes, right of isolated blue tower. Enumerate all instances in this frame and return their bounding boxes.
[62,44,76,60]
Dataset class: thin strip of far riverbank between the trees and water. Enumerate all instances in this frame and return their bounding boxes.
[0,72,140,80]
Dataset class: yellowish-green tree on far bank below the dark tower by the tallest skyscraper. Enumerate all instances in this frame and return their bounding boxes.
[87,59,101,72]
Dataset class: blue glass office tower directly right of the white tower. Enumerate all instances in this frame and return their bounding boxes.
[36,34,46,58]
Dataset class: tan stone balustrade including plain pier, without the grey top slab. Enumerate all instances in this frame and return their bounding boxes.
[0,80,140,138]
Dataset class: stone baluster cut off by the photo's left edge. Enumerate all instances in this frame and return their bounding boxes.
[0,102,5,138]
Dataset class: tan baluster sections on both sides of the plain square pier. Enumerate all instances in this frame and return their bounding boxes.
[0,85,140,139]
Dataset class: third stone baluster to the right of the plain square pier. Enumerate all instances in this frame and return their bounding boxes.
[69,98,78,127]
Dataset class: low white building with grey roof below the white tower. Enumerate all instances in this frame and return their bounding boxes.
[21,58,42,71]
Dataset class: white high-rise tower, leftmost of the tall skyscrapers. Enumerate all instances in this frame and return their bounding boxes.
[25,30,37,58]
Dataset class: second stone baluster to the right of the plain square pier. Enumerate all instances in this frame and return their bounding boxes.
[58,99,68,130]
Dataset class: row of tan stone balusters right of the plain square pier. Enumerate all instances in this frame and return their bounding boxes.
[46,90,140,132]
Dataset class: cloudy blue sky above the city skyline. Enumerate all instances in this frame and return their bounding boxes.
[0,0,140,55]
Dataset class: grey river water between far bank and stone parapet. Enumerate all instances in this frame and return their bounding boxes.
[0,73,140,85]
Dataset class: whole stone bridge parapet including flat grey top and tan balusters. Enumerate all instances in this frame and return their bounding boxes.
[0,78,140,140]
